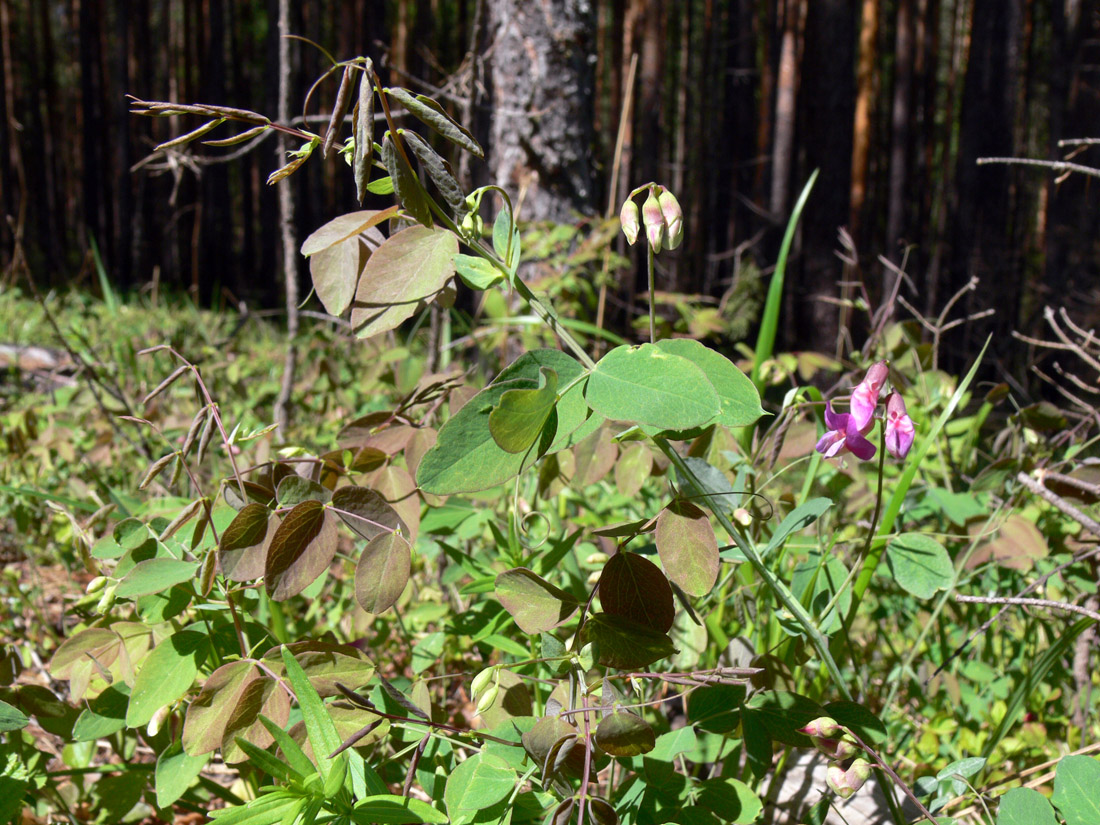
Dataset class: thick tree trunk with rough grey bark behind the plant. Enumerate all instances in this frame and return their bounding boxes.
[487,0,594,221]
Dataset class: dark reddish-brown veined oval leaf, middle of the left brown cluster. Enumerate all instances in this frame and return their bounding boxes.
[264,499,337,602]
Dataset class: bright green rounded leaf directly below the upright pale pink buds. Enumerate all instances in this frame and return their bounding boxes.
[585,344,722,430]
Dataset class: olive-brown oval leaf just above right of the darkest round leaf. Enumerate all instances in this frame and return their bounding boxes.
[656,499,719,597]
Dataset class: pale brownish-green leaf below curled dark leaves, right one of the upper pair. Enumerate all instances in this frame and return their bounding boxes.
[351,227,459,338]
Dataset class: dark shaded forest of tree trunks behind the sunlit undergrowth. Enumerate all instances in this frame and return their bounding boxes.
[0,0,1100,367]
